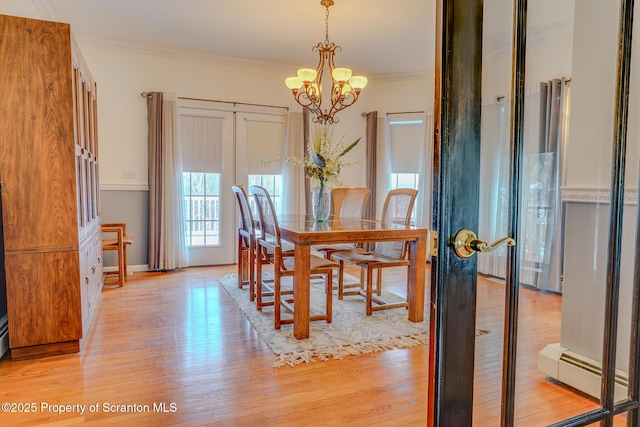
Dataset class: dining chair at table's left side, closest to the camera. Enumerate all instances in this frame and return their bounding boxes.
[250,185,338,329]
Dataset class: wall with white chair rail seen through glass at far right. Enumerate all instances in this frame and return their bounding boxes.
[560,0,640,371]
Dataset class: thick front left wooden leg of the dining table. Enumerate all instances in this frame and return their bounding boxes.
[293,245,311,339]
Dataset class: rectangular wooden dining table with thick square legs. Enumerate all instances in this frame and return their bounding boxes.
[278,214,429,339]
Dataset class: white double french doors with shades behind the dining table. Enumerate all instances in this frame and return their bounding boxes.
[179,99,284,266]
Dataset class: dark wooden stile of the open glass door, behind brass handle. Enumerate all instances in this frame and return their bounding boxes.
[428,0,483,427]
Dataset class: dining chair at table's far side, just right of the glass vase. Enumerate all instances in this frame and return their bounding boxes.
[313,187,370,259]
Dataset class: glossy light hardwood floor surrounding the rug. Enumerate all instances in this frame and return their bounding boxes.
[0,266,616,426]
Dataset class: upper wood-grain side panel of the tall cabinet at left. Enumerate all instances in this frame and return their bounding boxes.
[0,16,78,249]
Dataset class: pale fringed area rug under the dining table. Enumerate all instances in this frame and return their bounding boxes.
[219,274,488,367]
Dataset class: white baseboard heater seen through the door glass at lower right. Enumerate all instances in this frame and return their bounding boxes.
[538,343,629,401]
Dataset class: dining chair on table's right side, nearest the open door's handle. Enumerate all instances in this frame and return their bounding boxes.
[332,188,418,316]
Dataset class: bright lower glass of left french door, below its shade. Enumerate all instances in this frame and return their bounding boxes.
[182,172,220,246]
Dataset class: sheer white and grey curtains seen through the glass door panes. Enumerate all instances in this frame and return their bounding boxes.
[478,79,569,292]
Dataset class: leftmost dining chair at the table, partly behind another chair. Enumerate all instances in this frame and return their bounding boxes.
[231,185,256,301]
